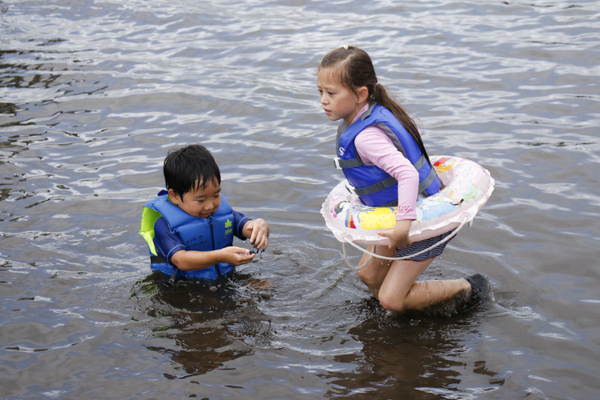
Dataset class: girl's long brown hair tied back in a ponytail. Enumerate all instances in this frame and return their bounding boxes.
[319,46,429,159]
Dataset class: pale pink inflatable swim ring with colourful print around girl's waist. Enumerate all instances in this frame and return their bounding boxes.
[321,156,494,245]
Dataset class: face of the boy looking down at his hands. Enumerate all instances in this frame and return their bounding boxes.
[169,181,221,218]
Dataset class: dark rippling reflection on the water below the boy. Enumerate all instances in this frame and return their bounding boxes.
[132,273,272,379]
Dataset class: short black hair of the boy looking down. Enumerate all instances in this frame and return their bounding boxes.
[163,144,221,201]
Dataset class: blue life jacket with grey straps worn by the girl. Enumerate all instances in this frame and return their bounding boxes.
[334,103,441,207]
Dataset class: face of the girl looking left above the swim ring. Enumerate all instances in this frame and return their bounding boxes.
[317,68,368,125]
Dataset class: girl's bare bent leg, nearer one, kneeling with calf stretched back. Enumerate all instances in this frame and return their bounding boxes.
[378,258,471,311]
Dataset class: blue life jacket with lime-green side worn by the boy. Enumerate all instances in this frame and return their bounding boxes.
[139,190,234,281]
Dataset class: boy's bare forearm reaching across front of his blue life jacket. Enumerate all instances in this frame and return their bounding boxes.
[171,246,255,271]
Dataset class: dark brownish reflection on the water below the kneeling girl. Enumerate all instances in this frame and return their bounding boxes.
[324,298,504,399]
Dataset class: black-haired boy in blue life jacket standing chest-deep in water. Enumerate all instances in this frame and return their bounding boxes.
[140,145,270,280]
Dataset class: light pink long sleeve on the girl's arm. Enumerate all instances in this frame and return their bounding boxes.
[354,126,419,220]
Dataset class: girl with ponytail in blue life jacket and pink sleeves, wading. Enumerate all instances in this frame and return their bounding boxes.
[317,46,489,311]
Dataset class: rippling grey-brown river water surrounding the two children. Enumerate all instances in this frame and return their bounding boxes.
[0,0,600,399]
